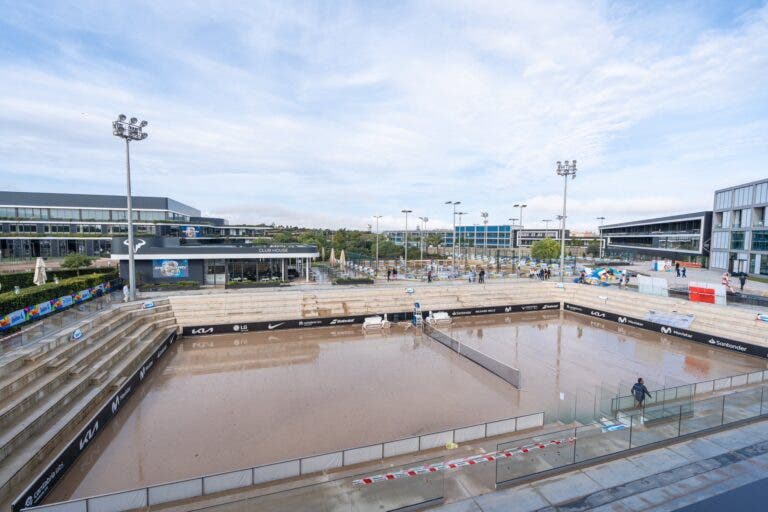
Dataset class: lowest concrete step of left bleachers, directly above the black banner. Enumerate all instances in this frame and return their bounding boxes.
[0,326,176,501]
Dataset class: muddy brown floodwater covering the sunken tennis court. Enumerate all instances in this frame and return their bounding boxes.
[47,313,765,502]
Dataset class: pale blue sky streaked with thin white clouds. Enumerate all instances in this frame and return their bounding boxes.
[0,0,768,229]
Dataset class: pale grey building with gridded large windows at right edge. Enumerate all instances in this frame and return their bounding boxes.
[710,179,768,275]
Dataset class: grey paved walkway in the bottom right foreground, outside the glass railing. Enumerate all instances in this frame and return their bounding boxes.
[432,420,768,512]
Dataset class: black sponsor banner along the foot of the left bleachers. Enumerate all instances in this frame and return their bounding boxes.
[11,332,176,512]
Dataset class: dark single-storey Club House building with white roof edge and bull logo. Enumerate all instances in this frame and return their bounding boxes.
[111,236,319,286]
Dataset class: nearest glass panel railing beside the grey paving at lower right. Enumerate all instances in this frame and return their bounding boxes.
[496,386,768,485]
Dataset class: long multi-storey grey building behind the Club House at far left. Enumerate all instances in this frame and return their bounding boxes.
[0,191,268,260]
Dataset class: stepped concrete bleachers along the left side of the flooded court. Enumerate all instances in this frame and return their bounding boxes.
[0,299,178,503]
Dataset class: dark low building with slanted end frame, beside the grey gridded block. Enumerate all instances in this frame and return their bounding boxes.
[600,211,712,266]
